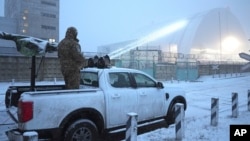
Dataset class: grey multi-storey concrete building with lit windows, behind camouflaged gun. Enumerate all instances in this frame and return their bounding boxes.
[1,0,59,41]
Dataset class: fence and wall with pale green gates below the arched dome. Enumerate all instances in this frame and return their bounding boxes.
[110,50,250,80]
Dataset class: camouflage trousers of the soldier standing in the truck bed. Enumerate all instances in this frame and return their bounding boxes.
[61,69,80,89]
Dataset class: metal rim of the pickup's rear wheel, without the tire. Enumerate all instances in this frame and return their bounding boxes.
[72,127,92,141]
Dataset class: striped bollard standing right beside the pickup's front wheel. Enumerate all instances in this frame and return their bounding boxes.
[175,103,184,140]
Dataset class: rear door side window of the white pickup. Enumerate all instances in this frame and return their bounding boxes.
[109,72,131,88]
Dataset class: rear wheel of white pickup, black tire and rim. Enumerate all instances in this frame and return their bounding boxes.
[64,119,99,141]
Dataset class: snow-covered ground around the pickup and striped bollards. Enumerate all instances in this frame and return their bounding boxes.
[0,73,250,141]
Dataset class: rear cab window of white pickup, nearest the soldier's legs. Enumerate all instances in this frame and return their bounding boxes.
[80,72,99,87]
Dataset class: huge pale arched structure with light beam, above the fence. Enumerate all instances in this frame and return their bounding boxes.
[98,8,249,61]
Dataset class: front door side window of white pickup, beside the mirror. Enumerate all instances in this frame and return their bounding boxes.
[133,73,156,87]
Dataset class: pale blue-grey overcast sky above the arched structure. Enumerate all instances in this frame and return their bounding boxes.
[0,0,250,51]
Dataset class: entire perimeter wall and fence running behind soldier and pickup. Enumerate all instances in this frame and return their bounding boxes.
[0,50,250,81]
